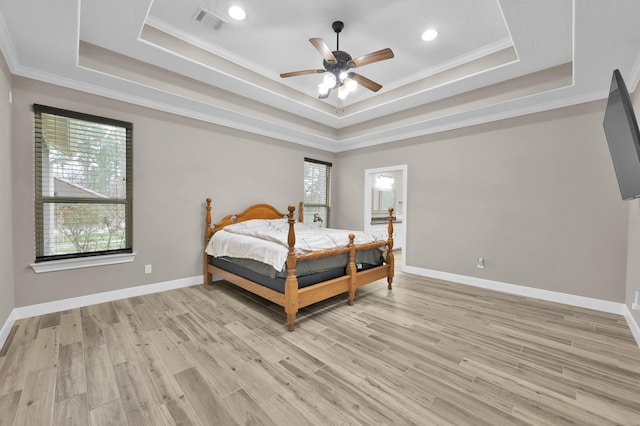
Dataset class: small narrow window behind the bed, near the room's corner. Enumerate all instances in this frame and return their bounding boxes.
[304,158,331,228]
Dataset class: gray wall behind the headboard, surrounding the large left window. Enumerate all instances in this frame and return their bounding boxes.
[11,77,334,306]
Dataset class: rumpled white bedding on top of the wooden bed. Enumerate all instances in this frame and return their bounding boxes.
[206,219,382,271]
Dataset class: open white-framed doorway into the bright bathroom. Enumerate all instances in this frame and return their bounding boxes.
[364,164,408,268]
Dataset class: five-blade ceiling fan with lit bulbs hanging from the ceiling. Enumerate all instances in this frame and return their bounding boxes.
[280,21,393,99]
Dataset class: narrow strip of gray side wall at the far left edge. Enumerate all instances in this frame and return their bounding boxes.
[0,53,15,328]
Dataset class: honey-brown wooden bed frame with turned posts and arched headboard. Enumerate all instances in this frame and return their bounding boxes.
[204,198,394,331]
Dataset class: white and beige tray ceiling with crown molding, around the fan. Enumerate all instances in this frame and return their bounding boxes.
[0,0,640,152]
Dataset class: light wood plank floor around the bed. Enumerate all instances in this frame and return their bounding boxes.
[0,262,640,426]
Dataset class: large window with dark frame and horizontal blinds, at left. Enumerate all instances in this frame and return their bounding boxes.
[33,105,133,263]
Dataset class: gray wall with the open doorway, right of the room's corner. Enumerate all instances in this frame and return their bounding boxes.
[334,101,628,302]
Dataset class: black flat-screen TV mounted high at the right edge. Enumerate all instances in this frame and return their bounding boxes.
[603,70,640,200]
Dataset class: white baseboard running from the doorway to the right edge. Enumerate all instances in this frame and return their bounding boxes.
[403,266,640,347]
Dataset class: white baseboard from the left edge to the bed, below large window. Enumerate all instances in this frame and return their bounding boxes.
[0,275,204,348]
